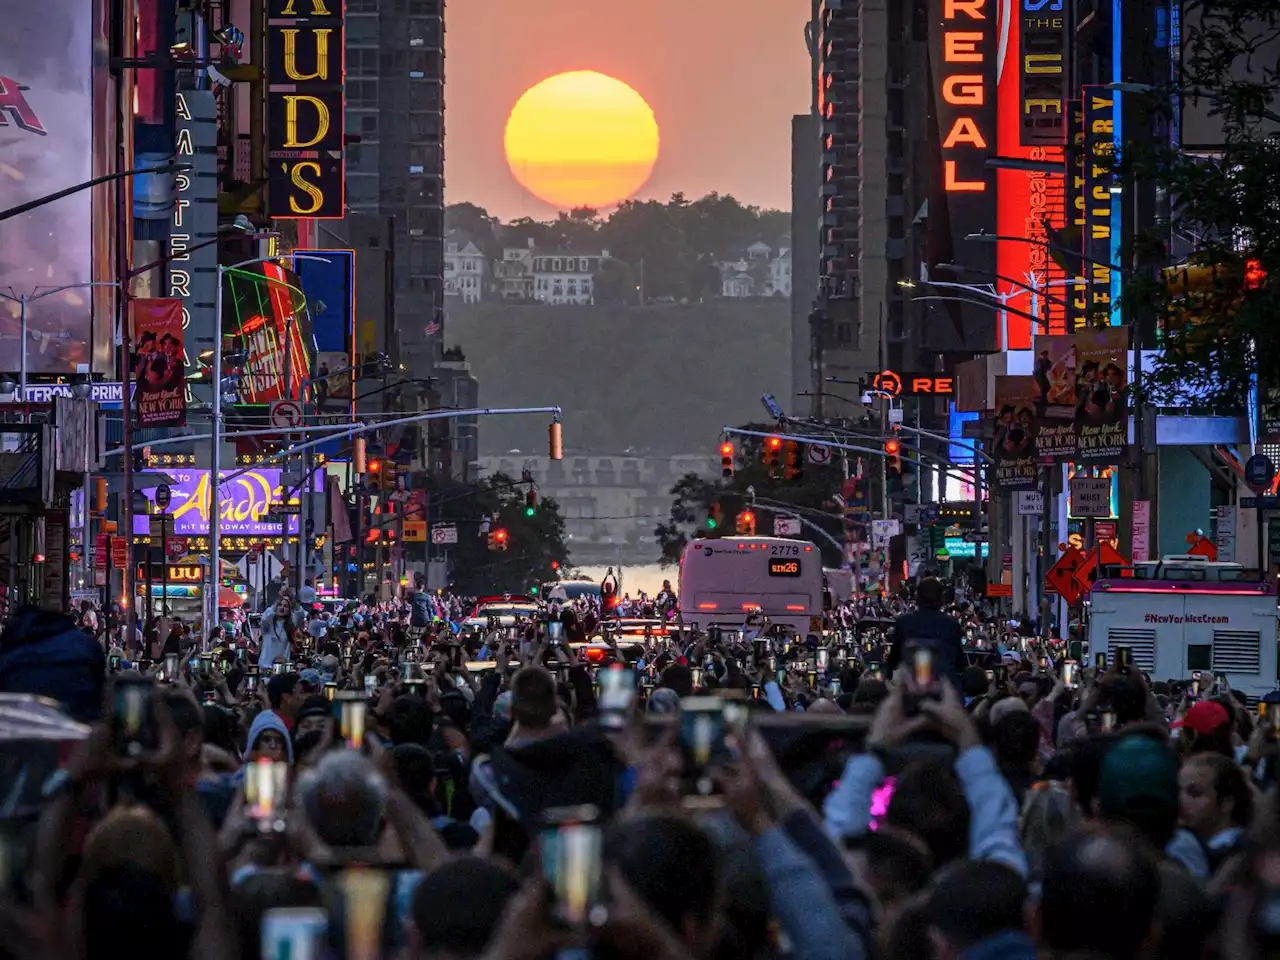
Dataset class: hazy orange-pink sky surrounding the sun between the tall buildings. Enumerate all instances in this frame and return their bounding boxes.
[444,0,809,220]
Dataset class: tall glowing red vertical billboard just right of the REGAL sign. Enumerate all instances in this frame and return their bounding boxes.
[996,0,1071,349]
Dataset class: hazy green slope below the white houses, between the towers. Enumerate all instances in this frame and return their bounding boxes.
[444,300,795,456]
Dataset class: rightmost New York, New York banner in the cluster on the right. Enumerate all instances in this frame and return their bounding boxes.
[1075,326,1129,463]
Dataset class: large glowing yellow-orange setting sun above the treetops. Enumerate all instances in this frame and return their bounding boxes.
[506,70,658,210]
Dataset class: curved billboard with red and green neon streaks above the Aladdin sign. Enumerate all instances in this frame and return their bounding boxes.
[223,262,316,403]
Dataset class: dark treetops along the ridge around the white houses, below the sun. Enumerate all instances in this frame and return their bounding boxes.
[444,193,791,301]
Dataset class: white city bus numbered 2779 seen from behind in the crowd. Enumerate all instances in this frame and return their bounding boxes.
[680,536,822,635]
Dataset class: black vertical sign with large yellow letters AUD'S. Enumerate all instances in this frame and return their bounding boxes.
[266,0,346,219]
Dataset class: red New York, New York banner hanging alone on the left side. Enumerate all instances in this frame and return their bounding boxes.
[129,298,187,426]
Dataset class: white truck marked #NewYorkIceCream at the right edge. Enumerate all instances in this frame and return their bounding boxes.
[1088,554,1277,701]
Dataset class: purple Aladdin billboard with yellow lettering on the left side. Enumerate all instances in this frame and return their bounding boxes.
[133,467,324,536]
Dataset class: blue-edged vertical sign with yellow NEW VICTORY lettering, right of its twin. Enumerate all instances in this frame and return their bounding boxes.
[1082,87,1116,326]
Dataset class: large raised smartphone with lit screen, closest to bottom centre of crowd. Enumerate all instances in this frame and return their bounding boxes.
[538,804,603,928]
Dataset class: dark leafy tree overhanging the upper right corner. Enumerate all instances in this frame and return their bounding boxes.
[1116,0,1280,415]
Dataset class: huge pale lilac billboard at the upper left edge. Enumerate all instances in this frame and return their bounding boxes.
[0,0,95,374]
